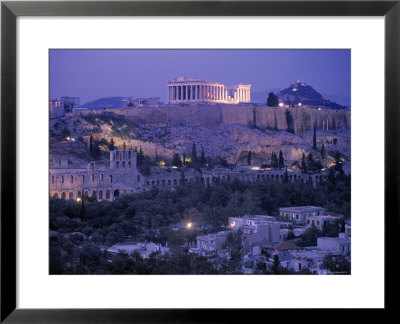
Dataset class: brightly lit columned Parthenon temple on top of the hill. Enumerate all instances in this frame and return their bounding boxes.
[167,77,251,104]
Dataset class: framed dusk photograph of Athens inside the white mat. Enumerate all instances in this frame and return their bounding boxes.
[49,49,351,275]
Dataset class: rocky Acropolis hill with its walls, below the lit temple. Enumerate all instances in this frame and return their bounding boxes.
[50,104,351,164]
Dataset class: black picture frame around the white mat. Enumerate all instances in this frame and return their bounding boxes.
[1,0,400,323]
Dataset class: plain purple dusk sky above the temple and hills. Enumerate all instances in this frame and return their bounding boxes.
[50,50,351,104]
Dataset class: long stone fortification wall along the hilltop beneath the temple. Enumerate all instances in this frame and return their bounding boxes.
[93,105,351,133]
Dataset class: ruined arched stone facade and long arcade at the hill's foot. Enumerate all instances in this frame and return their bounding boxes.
[49,150,327,201]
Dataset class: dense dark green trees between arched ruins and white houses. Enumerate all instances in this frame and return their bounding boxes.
[50,175,350,273]
